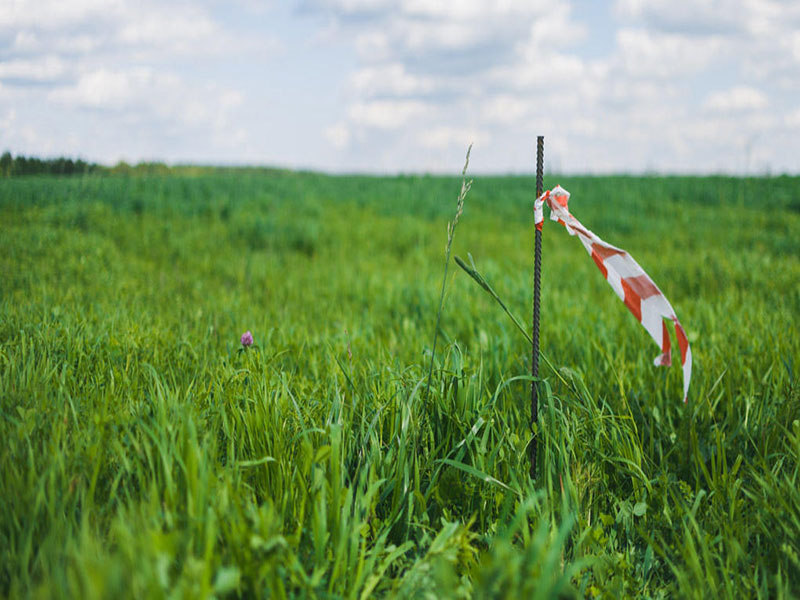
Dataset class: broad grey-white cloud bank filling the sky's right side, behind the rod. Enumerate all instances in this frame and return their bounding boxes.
[305,0,800,172]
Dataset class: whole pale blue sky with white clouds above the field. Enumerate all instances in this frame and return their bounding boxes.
[0,0,800,174]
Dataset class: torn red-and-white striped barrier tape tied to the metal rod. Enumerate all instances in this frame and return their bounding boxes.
[534,186,692,402]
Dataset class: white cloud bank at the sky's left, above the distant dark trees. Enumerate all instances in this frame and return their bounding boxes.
[0,0,277,160]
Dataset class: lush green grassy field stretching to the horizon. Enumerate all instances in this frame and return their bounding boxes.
[0,168,800,598]
